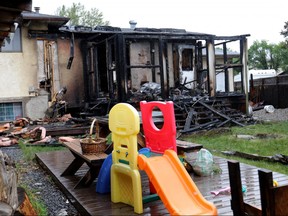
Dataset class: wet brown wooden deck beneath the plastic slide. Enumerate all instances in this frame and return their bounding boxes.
[36,150,288,215]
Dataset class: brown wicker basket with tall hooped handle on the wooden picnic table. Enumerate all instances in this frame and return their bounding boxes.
[80,118,106,154]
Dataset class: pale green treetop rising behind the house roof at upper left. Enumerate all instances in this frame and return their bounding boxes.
[56,3,109,27]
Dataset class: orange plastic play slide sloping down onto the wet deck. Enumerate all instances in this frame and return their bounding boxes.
[138,150,217,215]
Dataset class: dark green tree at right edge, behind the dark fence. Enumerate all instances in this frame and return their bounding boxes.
[248,40,288,71]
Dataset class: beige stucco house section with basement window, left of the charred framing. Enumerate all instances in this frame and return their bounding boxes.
[0,8,83,121]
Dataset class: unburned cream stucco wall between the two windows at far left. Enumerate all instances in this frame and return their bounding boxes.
[0,28,48,120]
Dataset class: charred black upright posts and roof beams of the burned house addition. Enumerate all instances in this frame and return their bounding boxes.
[79,29,249,109]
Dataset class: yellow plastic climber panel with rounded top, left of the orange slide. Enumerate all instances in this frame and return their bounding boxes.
[109,103,143,214]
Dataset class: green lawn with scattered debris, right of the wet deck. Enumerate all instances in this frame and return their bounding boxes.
[181,121,288,175]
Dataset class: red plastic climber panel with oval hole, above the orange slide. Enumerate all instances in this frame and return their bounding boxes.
[140,101,177,154]
